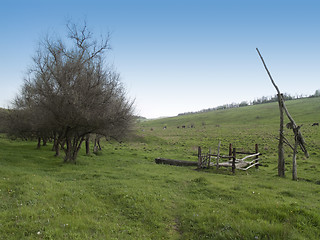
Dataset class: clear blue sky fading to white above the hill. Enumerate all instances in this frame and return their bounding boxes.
[0,0,320,118]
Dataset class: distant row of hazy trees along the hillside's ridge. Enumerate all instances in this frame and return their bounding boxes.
[178,89,320,116]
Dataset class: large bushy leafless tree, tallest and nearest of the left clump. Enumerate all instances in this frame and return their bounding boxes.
[15,23,133,163]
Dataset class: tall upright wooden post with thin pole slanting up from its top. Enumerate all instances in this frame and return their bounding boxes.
[256,48,285,177]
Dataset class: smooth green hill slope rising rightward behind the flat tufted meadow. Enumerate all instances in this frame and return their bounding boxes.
[143,98,320,127]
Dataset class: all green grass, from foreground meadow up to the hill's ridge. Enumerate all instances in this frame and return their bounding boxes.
[0,98,320,239]
